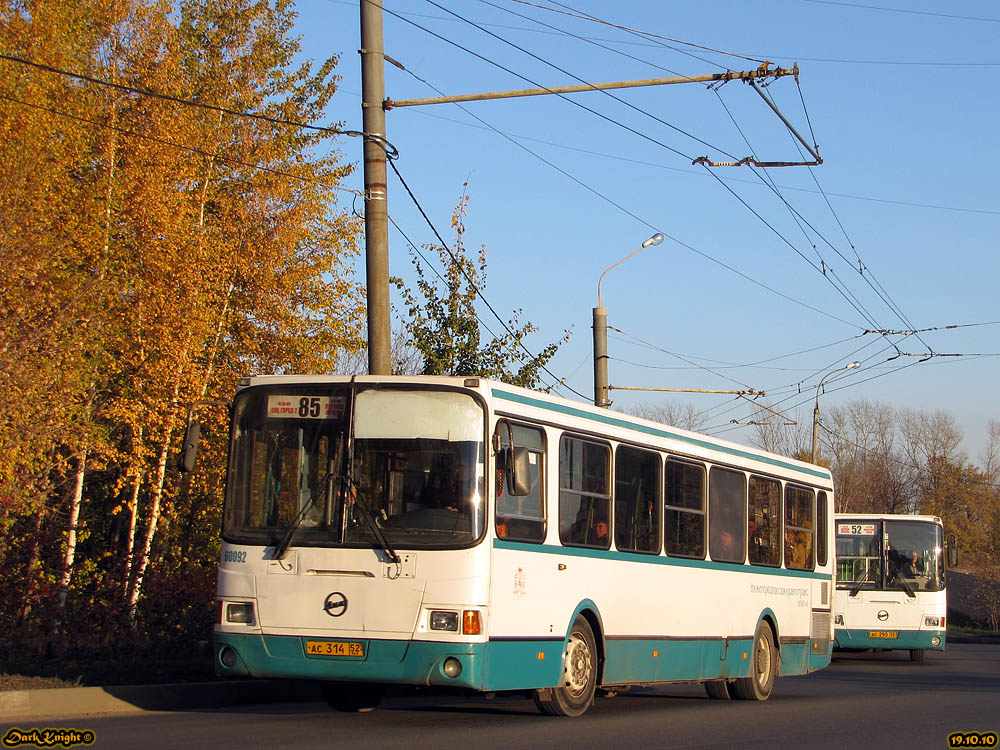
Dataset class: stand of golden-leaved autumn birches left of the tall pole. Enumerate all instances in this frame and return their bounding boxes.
[0,0,364,647]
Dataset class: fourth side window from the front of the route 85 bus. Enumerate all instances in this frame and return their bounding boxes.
[663,458,705,559]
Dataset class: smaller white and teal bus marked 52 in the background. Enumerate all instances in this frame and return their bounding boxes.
[834,513,954,661]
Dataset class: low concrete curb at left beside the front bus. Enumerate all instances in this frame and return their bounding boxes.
[0,680,322,722]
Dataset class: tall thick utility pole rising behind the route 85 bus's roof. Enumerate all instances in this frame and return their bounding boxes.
[360,0,392,375]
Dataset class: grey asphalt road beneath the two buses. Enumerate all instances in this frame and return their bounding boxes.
[0,644,1000,750]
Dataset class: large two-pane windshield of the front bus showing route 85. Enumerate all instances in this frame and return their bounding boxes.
[223,384,485,548]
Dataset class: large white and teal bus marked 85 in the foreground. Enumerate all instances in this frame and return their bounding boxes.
[214,376,833,716]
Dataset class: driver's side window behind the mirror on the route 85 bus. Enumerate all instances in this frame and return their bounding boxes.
[494,420,545,542]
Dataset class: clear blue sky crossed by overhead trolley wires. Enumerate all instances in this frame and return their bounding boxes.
[298,0,1000,461]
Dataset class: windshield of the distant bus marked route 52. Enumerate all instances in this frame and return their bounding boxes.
[837,519,945,593]
